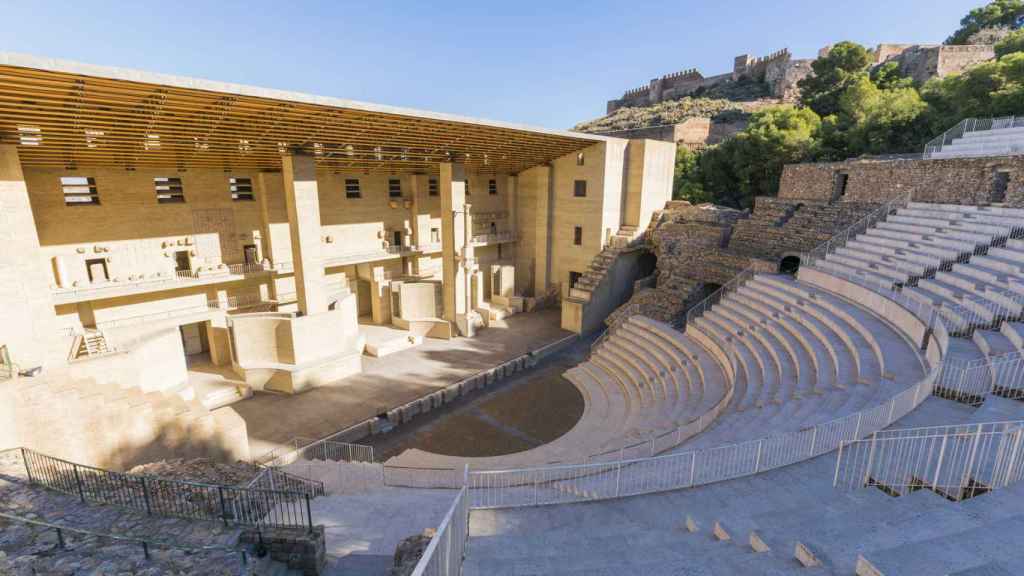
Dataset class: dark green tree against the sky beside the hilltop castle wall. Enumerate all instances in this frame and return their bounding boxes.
[797,42,871,118]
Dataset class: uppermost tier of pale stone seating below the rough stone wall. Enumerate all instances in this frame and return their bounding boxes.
[813,202,1024,398]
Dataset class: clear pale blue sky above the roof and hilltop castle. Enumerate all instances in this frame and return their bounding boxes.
[0,0,983,128]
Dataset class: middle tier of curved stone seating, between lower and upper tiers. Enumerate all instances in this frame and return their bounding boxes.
[676,274,926,451]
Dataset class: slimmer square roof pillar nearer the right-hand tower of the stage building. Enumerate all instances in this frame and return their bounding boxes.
[437,162,476,336]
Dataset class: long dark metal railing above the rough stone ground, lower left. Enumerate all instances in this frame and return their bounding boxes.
[22,448,312,530]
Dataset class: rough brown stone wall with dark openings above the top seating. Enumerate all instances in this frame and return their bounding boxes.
[778,156,1024,205]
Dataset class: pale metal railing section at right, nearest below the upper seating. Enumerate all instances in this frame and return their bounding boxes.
[833,420,1024,494]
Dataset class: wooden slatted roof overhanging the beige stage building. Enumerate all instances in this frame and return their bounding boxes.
[0,52,608,172]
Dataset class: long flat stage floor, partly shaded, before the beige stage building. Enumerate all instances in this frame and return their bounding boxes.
[229,308,569,457]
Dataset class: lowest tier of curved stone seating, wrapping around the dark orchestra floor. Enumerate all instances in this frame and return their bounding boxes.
[385,316,727,469]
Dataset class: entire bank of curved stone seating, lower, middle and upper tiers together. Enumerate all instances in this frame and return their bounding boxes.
[388,203,1024,469]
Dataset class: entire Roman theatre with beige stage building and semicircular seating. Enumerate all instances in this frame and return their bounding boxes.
[0,53,1024,576]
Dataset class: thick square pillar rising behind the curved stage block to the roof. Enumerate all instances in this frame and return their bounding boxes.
[281,154,327,316]
